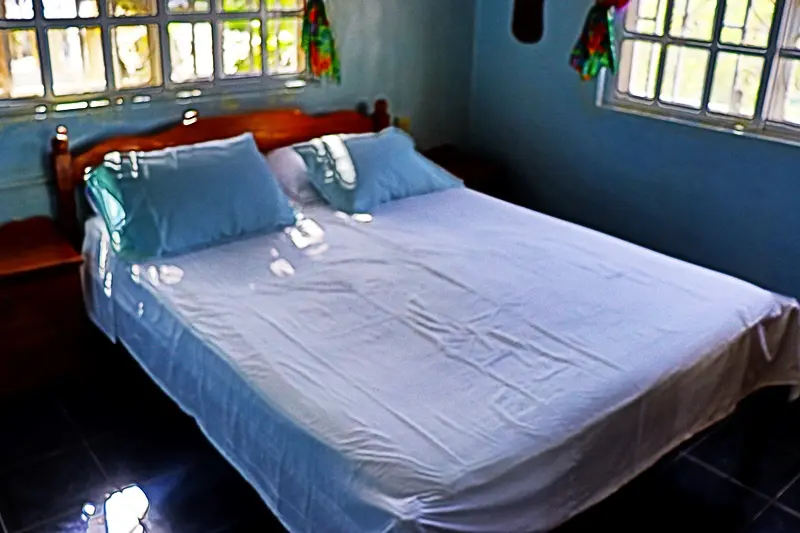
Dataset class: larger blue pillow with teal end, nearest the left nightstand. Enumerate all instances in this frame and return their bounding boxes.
[86,133,295,261]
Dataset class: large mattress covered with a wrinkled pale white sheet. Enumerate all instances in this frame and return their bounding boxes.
[84,189,800,533]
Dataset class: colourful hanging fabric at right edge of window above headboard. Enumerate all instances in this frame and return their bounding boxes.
[303,0,342,83]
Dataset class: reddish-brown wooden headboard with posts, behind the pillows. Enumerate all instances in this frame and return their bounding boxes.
[51,100,391,244]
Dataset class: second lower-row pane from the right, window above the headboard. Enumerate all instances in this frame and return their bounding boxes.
[221,19,262,76]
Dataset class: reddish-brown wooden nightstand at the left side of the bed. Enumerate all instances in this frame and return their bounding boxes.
[0,217,92,394]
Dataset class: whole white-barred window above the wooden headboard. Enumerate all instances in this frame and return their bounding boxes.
[0,0,306,111]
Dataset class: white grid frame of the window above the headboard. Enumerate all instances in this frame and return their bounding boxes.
[0,0,309,116]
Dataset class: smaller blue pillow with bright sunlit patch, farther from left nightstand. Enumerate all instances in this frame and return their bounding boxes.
[294,128,463,214]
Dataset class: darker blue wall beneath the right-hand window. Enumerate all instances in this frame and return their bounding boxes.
[471,0,800,296]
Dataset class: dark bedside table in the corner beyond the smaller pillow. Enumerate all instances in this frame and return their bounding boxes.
[422,144,507,199]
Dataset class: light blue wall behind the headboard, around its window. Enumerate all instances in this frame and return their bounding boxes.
[0,0,474,222]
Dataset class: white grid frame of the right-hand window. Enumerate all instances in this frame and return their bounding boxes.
[596,0,800,146]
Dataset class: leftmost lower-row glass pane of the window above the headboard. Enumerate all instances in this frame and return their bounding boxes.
[0,30,44,99]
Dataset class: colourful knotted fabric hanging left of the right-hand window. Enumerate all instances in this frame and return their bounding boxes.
[569,0,630,80]
